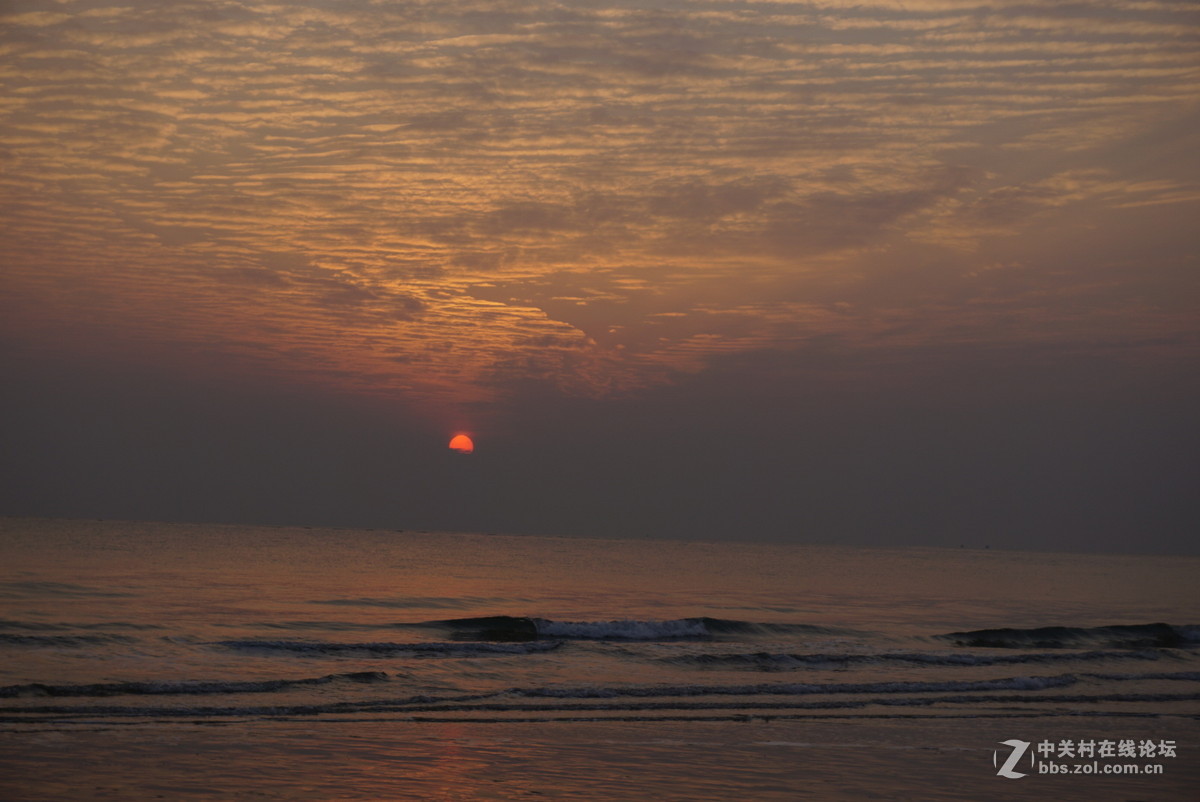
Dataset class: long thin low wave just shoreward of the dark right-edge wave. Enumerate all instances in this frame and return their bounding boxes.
[659,650,1171,671]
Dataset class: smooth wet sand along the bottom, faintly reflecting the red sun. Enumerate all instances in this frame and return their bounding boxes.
[0,717,1200,802]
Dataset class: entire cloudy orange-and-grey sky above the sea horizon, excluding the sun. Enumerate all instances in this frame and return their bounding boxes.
[0,0,1200,553]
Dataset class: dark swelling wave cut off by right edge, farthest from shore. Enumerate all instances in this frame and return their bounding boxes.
[937,623,1200,648]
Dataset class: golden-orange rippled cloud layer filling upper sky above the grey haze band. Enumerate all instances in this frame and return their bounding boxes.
[0,0,1200,422]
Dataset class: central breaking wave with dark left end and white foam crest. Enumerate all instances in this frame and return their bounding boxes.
[427,616,847,641]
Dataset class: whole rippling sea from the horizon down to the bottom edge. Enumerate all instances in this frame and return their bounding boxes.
[0,519,1200,801]
